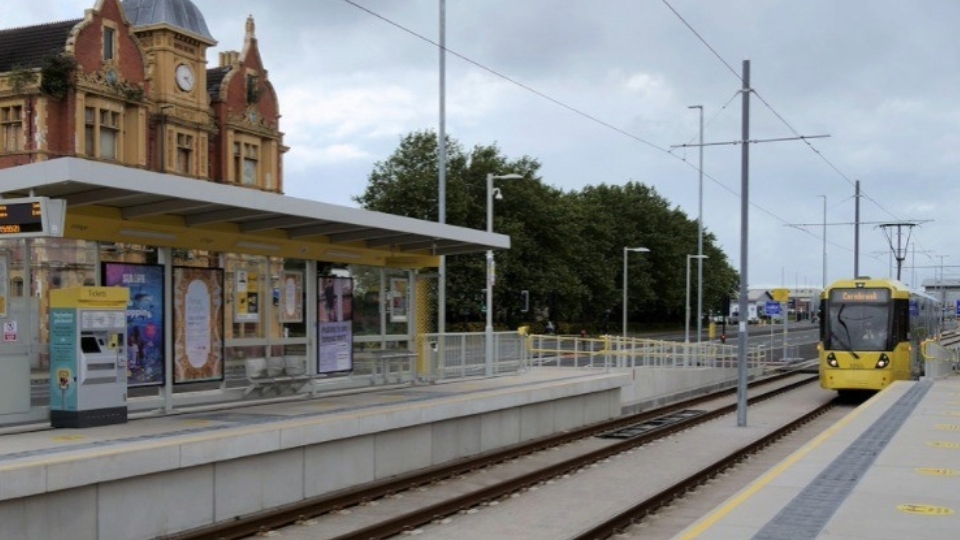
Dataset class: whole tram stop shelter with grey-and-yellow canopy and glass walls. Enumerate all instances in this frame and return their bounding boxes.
[0,157,510,427]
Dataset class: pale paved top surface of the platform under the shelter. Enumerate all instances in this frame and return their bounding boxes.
[0,368,627,501]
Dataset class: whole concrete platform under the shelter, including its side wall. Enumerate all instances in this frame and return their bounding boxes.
[0,368,630,540]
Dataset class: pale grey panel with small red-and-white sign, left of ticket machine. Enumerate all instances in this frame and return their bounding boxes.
[0,294,40,414]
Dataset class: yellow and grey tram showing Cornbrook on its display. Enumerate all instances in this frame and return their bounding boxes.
[819,277,939,392]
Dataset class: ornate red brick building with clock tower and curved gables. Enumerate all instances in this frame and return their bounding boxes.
[0,0,286,193]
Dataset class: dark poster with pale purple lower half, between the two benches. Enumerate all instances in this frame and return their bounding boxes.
[317,276,353,373]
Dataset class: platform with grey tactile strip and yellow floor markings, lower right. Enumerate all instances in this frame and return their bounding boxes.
[675,377,960,540]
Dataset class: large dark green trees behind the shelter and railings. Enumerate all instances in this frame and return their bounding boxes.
[355,131,739,335]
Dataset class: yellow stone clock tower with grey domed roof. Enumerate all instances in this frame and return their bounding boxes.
[121,0,217,178]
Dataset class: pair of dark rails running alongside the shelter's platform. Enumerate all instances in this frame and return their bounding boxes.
[165,373,816,540]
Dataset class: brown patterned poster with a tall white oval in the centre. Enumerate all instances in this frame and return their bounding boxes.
[173,266,224,384]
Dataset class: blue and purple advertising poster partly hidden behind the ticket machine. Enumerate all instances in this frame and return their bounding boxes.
[100,262,166,387]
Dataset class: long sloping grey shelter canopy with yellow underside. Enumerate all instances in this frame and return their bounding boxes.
[0,158,510,268]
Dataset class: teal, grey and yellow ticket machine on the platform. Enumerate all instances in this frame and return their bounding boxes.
[50,287,130,428]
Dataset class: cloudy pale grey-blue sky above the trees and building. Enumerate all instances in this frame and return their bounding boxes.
[0,0,960,288]
